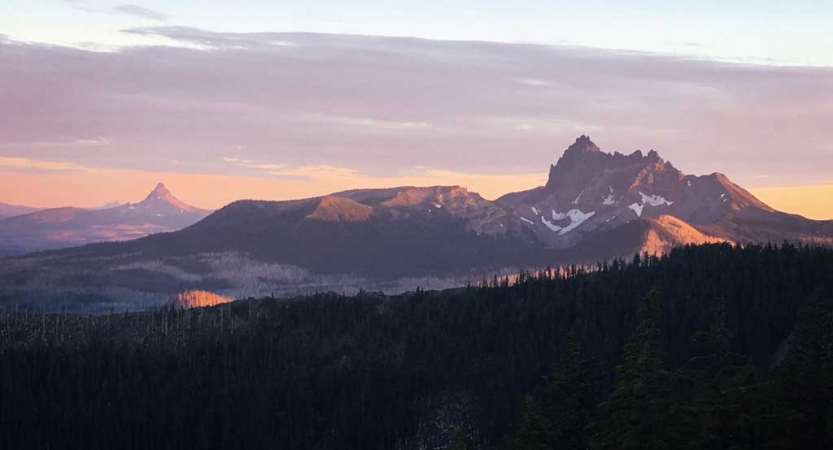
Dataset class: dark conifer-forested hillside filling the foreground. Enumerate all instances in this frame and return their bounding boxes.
[0,245,833,450]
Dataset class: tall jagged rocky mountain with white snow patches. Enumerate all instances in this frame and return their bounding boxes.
[497,136,833,248]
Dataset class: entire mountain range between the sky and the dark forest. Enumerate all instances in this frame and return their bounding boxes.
[0,136,833,309]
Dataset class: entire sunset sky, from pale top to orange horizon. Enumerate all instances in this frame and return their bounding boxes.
[0,0,833,218]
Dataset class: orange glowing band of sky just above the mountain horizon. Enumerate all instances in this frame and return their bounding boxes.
[0,170,833,220]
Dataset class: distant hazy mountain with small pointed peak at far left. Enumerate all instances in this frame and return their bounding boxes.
[0,183,209,250]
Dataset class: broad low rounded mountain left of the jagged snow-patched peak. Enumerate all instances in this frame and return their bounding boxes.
[57,187,546,279]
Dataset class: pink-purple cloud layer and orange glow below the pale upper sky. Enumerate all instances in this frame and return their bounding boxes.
[0,27,833,218]
